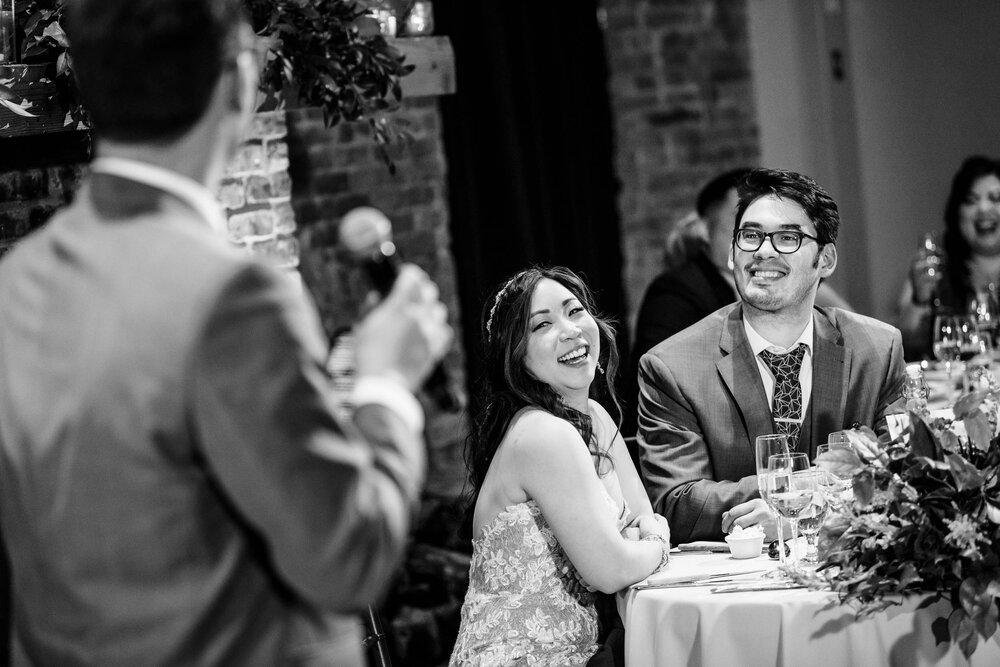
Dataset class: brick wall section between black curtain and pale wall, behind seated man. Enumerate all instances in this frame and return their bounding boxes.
[603,0,760,330]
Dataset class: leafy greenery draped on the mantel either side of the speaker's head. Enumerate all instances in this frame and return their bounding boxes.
[0,0,413,170]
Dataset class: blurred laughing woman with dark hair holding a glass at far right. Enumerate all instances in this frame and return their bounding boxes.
[897,155,1000,359]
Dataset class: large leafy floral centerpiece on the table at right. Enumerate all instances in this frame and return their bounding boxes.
[817,392,1000,657]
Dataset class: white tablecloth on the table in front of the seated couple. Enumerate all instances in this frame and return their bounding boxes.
[618,554,1000,667]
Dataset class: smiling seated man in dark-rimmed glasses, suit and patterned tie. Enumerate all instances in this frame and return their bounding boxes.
[638,169,904,543]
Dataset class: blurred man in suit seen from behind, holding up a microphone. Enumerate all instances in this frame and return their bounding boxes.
[0,0,451,665]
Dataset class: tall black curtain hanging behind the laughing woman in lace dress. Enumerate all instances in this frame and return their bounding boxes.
[434,0,628,404]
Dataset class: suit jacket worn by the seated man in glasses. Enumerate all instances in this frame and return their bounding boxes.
[638,303,904,543]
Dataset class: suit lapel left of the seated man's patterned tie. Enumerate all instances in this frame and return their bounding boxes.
[716,305,774,447]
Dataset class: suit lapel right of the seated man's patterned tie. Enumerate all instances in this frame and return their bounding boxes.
[809,309,852,452]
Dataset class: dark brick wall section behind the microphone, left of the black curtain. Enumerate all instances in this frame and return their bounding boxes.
[288,98,466,496]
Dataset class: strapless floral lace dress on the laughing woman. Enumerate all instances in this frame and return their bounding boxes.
[449,493,628,667]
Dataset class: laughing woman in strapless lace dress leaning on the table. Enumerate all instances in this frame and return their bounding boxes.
[450,267,670,667]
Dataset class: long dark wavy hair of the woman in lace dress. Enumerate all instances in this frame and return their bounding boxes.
[465,266,621,506]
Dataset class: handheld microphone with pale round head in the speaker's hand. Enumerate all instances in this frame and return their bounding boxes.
[339,206,464,412]
